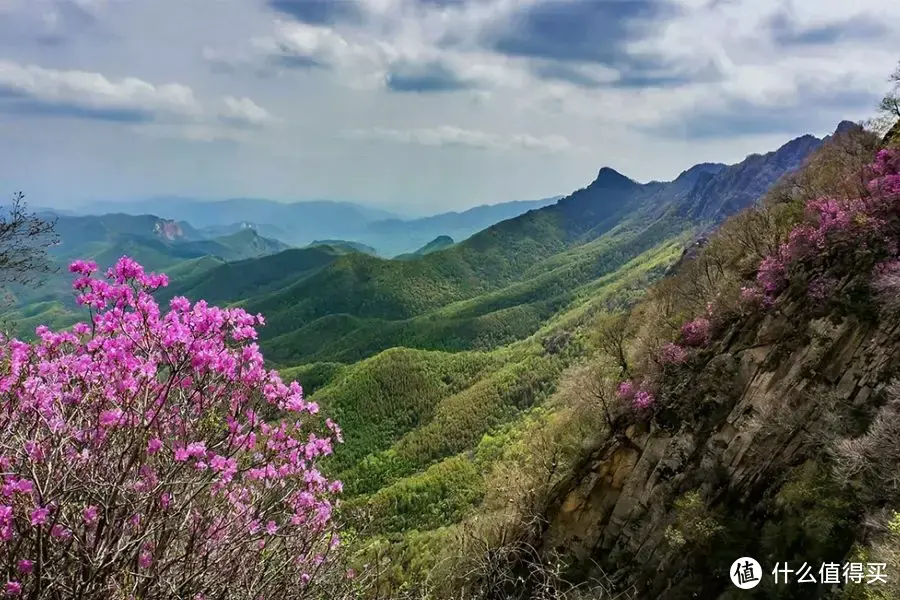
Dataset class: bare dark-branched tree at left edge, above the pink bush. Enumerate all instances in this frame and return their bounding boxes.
[0,192,59,287]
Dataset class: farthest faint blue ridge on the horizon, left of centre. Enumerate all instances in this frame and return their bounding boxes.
[77,197,397,246]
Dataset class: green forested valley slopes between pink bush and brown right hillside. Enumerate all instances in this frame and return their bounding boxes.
[3,127,828,586]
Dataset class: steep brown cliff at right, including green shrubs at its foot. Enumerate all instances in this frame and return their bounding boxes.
[541,288,900,600]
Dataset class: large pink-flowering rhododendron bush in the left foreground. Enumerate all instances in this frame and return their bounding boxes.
[0,258,341,600]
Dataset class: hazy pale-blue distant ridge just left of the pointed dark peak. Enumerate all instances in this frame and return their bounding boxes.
[353,196,561,256]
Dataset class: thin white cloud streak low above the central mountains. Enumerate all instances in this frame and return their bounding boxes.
[344,125,574,153]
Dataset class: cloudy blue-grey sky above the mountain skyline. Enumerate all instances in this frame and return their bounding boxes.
[0,0,900,214]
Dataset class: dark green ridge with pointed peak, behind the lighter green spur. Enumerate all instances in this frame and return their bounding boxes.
[167,131,821,364]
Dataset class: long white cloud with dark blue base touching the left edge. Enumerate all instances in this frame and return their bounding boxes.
[0,60,272,126]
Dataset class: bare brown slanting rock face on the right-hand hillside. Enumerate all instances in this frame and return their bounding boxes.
[542,302,900,600]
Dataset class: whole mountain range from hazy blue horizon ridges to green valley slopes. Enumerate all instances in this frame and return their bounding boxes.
[7,124,868,596]
